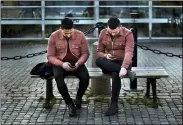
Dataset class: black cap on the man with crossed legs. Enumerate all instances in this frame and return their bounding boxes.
[107,17,120,29]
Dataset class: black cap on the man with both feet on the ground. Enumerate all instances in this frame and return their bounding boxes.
[61,18,73,30]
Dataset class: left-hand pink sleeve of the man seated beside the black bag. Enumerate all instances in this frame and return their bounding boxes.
[47,34,63,66]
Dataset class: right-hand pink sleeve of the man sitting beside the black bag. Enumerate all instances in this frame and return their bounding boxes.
[77,33,90,65]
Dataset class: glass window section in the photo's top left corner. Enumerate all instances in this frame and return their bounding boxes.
[1,1,41,19]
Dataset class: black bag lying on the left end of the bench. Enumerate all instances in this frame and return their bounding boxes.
[30,62,53,79]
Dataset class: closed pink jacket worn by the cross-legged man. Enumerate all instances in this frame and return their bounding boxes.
[97,26,134,69]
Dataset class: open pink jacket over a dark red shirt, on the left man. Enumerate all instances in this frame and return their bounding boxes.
[47,29,89,66]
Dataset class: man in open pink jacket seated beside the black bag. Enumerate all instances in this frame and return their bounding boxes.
[47,18,89,116]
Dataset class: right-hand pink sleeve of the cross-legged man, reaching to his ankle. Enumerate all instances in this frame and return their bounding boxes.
[122,32,134,69]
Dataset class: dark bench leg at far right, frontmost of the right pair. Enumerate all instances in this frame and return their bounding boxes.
[151,79,158,108]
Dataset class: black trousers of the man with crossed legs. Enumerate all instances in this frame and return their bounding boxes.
[96,57,131,102]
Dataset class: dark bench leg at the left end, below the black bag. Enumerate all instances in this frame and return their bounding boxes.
[43,79,55,108]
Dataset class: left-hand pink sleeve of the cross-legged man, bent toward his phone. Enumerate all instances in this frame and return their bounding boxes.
[96,31,105,57]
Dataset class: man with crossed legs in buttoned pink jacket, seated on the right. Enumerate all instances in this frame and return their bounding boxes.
[96,17,135,116]
